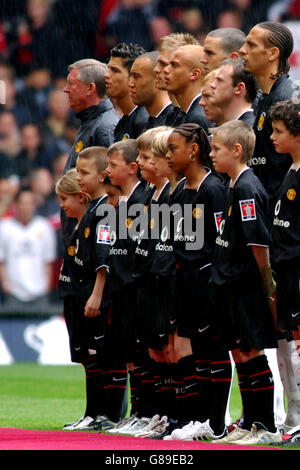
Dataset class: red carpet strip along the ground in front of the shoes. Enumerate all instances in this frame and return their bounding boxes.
[0,428,280,452]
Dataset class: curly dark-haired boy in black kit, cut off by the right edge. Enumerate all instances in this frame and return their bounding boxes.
[269,99,300,432]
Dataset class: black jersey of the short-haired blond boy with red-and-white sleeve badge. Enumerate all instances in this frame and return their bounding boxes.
[212,168,271,285]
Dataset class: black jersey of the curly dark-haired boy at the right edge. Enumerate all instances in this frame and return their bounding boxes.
[272,168,300,263]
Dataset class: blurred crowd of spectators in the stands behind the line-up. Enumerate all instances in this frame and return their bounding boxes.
[0,0,300,303]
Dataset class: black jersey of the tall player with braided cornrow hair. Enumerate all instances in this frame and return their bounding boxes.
[249,75,299,198]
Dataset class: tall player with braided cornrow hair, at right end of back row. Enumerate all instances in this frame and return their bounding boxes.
[240,21,299,213]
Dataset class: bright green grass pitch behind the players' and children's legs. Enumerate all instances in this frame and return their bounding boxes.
[0,363,241,430]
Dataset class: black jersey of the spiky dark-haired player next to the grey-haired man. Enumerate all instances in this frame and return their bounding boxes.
[114,106,149,142]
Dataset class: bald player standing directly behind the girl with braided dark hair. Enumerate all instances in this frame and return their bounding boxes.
[164,44,211,131]
